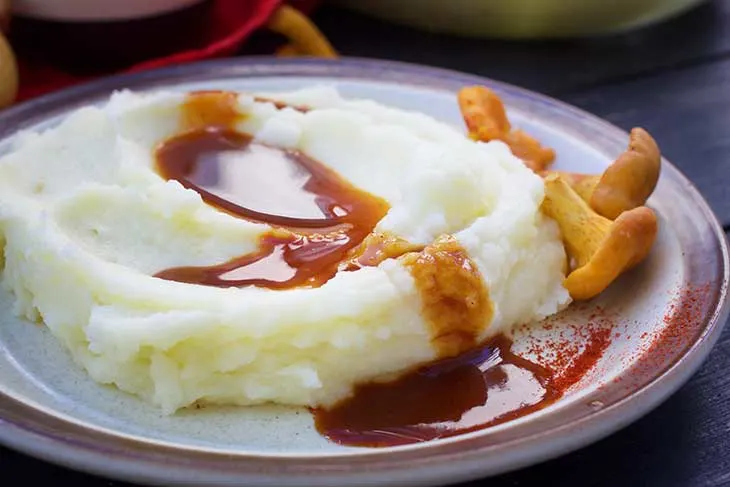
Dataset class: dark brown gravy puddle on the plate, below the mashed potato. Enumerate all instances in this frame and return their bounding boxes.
[314,337,561,446]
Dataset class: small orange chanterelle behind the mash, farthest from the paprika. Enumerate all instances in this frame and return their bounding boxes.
[457,86,555,172]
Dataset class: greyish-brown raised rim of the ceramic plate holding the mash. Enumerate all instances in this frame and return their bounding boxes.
[0,57,730,486]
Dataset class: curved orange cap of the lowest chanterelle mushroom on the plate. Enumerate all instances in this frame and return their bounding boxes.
[563,206,658,300]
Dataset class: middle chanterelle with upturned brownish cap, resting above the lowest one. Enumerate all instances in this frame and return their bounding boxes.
[548,127,661,220]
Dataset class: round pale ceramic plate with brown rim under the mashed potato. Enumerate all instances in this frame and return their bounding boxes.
[0,58,728,486]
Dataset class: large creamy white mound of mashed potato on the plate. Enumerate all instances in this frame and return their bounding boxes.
[0,87,569,413]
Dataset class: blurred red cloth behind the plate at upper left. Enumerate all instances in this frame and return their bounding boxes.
[17,0,318,101]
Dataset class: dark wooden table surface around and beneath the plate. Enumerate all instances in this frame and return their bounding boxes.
[0,0,730,487]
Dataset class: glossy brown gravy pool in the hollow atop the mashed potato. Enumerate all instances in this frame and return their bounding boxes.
[156,92,389,289]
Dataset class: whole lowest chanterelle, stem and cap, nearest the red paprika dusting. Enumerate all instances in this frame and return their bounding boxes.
[542,174,657,300]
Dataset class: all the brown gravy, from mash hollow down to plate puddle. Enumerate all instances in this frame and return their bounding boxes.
[156,91,560,446]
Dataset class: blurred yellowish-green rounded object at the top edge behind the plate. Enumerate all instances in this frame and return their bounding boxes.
[331,0,705,39]
